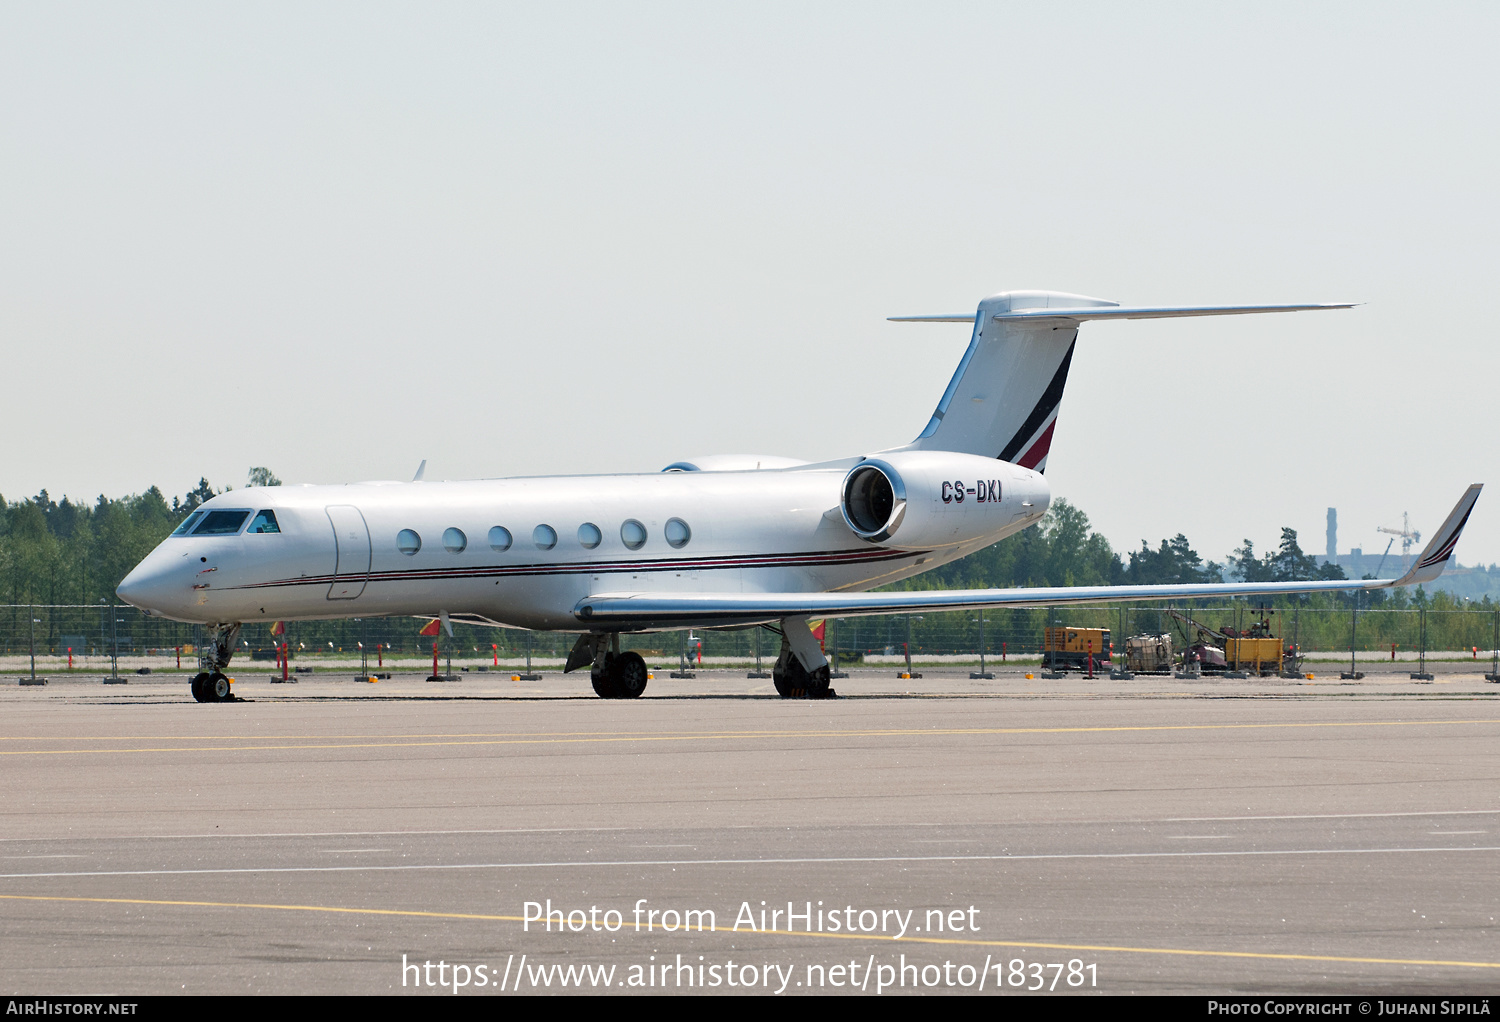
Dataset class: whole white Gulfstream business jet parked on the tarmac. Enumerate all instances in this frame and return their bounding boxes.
[119,291,1481,702]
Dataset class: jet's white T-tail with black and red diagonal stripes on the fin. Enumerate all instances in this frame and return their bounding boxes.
[891,291,1352,473]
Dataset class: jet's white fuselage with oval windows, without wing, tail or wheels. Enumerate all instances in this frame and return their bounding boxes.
[120,453,1050,630]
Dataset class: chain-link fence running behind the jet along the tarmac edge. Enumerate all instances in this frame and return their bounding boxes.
[0,600,1500,663]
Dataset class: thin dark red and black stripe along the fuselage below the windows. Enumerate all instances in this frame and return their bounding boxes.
[224,549,927,590]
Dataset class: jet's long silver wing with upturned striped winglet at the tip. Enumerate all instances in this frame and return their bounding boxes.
[575,483,1484,629]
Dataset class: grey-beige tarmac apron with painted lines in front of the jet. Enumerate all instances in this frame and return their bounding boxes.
[0,663,1500,996]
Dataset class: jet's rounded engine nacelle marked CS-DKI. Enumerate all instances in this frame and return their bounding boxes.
[840,450,1052,546]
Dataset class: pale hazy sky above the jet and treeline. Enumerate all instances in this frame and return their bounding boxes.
[0,0,1500,563]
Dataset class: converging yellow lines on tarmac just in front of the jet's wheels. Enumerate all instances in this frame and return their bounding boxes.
[0,719,1500,756]
